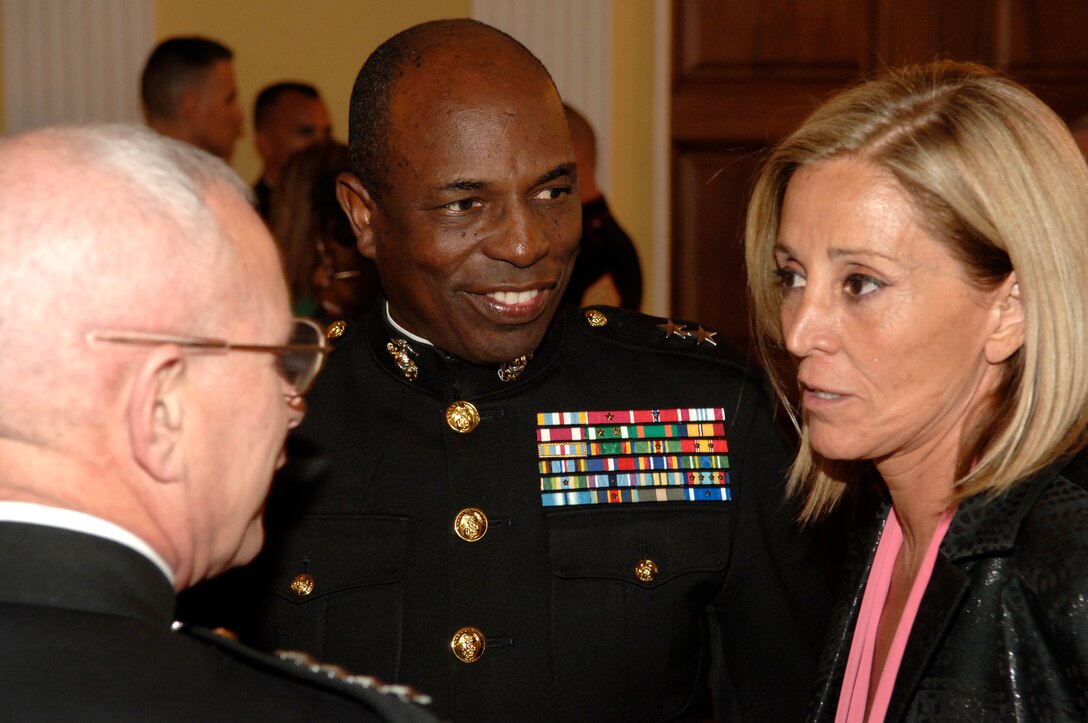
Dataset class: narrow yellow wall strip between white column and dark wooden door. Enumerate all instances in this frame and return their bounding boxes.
[608,0,668,310]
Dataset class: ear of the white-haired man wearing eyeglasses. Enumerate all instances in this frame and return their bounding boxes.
[127,346,185,483]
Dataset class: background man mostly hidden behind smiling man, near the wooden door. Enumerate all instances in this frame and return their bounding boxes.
[562,103,642,311]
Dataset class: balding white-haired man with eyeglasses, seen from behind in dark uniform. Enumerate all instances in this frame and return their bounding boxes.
[0,126,433,721]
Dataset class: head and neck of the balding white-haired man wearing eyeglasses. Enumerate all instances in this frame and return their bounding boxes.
[0,125,311,589]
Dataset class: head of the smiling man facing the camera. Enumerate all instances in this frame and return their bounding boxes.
[339,20,581,363]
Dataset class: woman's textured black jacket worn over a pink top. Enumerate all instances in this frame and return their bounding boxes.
[809,454,1088,723]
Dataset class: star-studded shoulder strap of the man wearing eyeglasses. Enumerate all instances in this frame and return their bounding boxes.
[175,624,436,723]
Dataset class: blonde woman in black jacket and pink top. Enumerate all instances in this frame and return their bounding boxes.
[745,62,1088,722]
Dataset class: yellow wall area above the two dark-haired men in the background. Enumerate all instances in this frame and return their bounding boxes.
[156,0,471,180]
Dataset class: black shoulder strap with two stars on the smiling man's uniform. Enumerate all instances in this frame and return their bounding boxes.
[571,307,754,370]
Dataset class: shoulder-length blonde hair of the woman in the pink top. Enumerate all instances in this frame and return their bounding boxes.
[745,61,1088,521]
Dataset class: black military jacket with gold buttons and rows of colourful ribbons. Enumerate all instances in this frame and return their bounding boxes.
[189,308,826,721]
